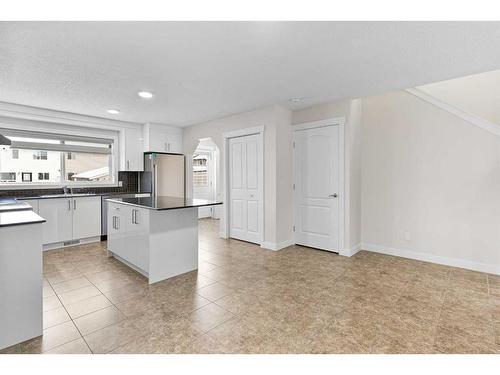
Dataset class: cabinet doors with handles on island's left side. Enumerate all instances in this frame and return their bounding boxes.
[108,202,149,271]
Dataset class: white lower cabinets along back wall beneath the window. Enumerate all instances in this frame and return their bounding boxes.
[38,196,101,245]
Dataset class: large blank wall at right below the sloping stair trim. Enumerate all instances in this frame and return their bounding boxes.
[361,91,500,273]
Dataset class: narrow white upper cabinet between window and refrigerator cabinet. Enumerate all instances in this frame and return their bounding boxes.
[120,127,144,171]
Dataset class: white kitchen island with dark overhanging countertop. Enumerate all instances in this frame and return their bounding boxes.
[107,196,222,284]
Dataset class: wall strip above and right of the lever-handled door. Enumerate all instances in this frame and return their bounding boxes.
[292,99,362,255]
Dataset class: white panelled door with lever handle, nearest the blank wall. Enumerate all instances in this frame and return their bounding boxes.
[294,126,340,251]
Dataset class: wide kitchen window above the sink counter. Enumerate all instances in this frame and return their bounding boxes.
[0,129,115,186]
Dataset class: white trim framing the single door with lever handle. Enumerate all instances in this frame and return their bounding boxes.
[293,117,346,255]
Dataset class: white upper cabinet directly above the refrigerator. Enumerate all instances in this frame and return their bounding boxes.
[143,124,182,154]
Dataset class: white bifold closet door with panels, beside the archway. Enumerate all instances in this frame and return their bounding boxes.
[228,134,262,244]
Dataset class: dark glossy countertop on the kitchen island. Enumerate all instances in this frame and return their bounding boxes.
[107,196,222,211]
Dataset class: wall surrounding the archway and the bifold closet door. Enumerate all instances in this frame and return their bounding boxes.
[183,106,293,250]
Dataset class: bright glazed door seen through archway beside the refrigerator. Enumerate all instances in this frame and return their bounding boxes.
[193,150,215,219]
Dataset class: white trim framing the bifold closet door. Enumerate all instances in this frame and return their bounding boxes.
[219,126,265,245]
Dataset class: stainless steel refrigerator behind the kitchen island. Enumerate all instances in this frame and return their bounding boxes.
[141,152,186,198]
